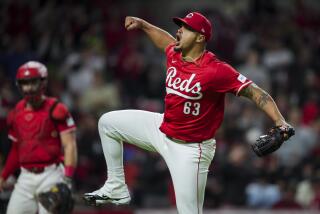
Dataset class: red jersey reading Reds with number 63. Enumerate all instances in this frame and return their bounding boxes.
[160,45,252,142]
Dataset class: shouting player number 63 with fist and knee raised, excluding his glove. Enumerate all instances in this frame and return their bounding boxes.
[84,12,296,214]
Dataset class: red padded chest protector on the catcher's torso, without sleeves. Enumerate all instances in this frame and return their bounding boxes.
[11,98,61,162]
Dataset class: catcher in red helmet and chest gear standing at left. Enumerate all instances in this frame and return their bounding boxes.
[0,61,77,214]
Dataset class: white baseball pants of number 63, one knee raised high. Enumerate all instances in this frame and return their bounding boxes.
[98,110,216,214]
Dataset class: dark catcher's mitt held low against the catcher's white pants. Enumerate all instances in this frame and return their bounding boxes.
[38,183,74,214]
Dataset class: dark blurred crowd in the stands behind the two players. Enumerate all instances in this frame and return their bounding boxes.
[0,0,320,214]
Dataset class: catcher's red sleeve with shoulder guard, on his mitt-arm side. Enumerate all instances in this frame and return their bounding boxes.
[52,103,76,133]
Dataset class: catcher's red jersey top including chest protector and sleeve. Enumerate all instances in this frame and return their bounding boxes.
[8,98,75,168]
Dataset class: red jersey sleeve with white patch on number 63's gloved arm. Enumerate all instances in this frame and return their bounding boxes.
[212,63,252,96]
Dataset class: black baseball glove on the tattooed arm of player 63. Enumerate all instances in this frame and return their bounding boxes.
[251,126,295,157]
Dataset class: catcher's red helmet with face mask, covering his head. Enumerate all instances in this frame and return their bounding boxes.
[16,61,48,104]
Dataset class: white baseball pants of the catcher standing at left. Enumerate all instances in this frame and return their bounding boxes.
[7,164,63,214]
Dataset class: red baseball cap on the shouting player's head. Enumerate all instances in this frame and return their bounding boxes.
[173,12,212,41]
